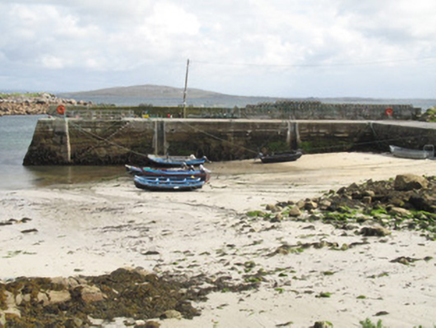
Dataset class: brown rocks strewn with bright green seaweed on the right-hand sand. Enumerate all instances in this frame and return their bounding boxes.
[257,174,436,240]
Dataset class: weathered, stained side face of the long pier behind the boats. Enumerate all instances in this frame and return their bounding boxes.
[24,118,436,165]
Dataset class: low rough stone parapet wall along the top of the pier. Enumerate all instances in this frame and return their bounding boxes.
[47,101,421,121]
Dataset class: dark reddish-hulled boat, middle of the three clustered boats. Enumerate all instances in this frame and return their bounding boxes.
[125,165,211,182]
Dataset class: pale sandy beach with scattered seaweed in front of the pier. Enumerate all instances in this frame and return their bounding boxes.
[0,153,436,328]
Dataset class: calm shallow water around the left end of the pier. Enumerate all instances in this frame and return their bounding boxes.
[0,115,125,190]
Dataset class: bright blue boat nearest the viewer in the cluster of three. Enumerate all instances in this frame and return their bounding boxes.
[133,175,206,191]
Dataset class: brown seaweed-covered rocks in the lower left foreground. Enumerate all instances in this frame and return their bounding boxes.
[0,269,200,328]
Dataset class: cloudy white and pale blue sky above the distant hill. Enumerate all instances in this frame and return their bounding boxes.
[0,0,436,98]
